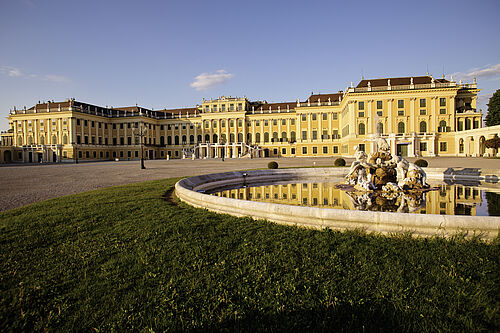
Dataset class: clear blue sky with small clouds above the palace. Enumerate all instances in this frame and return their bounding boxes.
[0,0,500,130]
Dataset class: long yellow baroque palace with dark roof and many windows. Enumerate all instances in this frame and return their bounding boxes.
[0,76,500,162]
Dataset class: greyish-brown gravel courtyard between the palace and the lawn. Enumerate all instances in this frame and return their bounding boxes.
[0,157,500,211]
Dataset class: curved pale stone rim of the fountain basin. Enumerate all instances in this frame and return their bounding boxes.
[175,168,500,239]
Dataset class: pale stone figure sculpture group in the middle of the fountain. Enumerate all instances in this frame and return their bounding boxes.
[339,137,430,212]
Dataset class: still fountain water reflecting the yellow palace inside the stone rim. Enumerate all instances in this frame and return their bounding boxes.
[206,180,500,216]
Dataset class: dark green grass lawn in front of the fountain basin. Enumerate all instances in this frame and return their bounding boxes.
[0,179,500,332]
